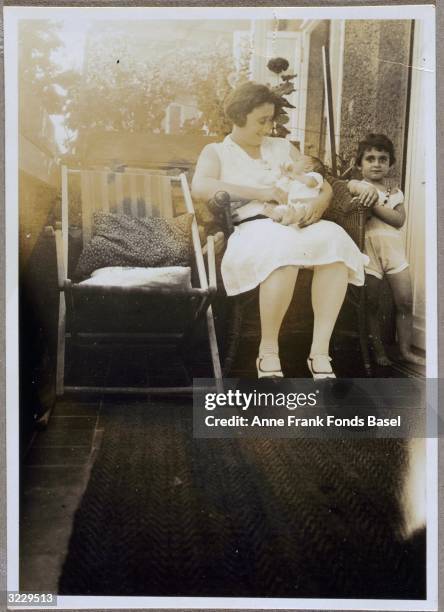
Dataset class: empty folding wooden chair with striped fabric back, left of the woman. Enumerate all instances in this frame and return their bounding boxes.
[47,166,222,396]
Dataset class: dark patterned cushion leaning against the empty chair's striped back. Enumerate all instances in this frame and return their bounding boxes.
[75,212,193,278]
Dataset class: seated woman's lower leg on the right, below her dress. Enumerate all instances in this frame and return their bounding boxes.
[310,262,348,372]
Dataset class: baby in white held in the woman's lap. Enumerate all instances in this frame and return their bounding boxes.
[263,156,324,227]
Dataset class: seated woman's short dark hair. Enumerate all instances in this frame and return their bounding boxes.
[224,82,278,127]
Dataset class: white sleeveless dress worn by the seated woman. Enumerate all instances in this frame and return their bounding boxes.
[212,136,368,295]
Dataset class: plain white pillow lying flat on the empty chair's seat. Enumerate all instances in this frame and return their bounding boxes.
[79,266,191,289]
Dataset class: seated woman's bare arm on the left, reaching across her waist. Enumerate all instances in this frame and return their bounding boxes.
[191,145,287,204]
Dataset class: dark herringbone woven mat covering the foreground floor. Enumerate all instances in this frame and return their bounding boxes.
[59,402,425,599]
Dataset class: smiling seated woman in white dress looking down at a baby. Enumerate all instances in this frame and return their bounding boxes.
[192,82,366,378]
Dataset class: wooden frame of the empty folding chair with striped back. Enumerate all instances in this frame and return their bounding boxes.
[47,166,222,396]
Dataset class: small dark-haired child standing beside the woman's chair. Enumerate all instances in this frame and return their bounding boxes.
[348,134,425,366]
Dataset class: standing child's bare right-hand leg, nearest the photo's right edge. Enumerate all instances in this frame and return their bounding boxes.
[387,269,425,365]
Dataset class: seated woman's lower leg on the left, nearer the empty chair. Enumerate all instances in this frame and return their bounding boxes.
[259,266,299,356]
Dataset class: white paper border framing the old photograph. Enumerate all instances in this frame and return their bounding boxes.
[3,4,439,610]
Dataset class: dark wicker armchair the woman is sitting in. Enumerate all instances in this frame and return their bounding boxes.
[208,185,372,377]
